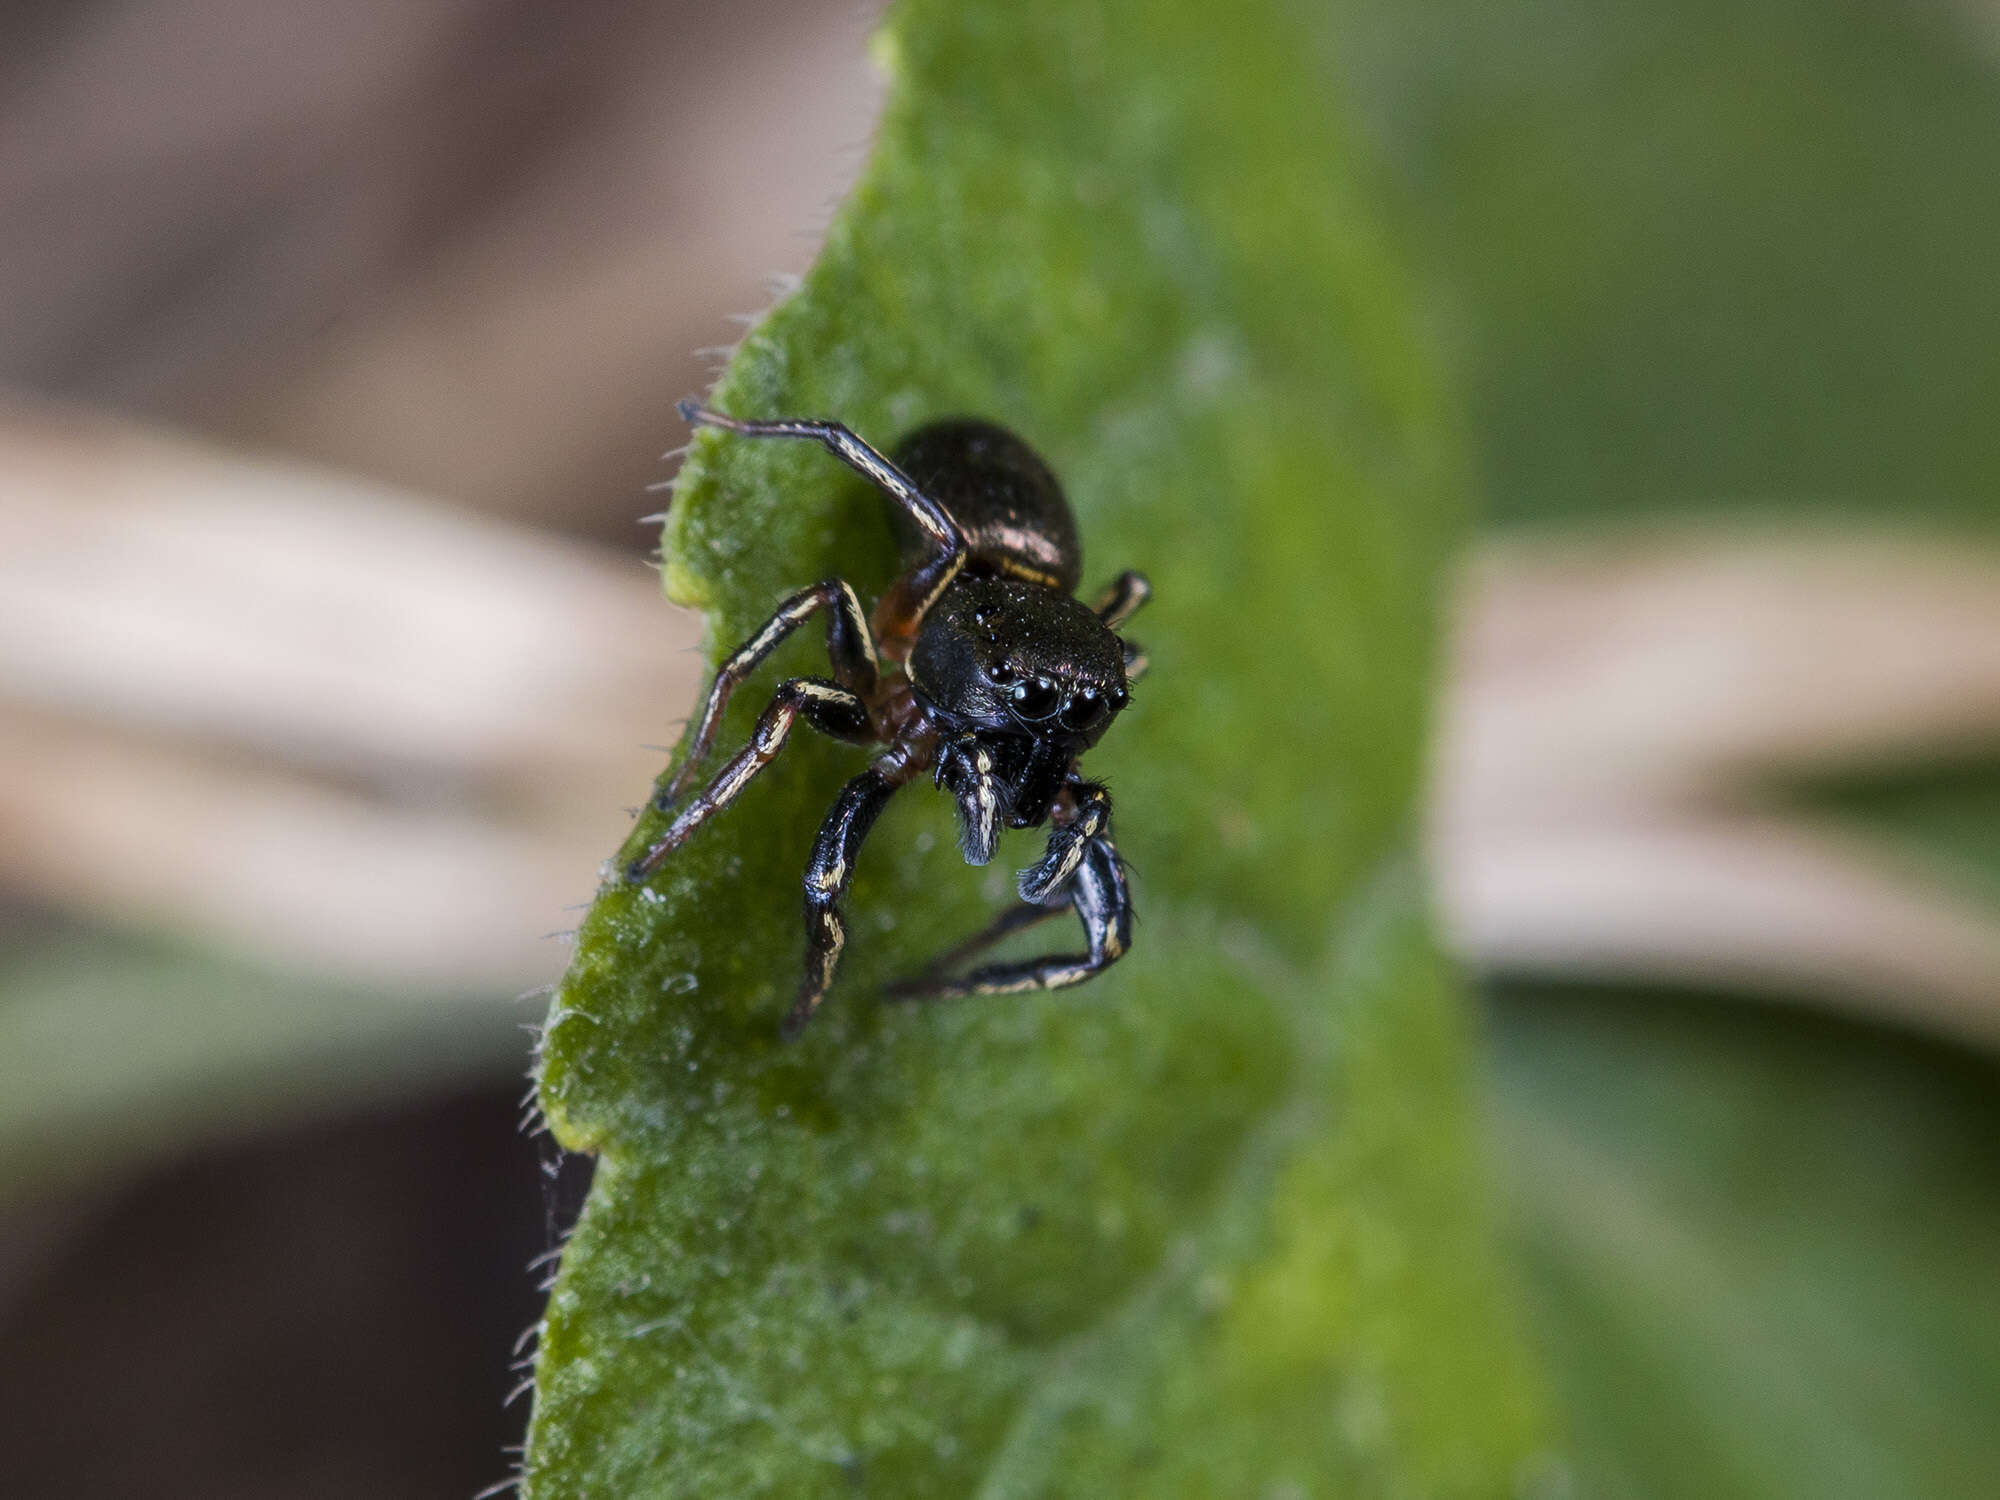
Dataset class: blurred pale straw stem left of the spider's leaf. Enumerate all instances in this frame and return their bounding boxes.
[0,402,698,992]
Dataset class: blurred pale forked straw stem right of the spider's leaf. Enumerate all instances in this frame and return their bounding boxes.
[1432,530,2000,1046]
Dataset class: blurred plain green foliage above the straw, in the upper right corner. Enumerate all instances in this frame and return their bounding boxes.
[1330,0,2000,530]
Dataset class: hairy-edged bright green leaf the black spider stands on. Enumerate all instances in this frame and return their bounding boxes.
[526,0,1540,1496]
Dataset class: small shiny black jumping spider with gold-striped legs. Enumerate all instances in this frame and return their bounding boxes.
[626,402,1152,1038]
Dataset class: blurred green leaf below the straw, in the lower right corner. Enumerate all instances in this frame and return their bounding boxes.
[1494,986,2000,1500]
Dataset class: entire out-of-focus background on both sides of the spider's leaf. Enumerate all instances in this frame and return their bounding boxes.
[0,0,2000,1496]
